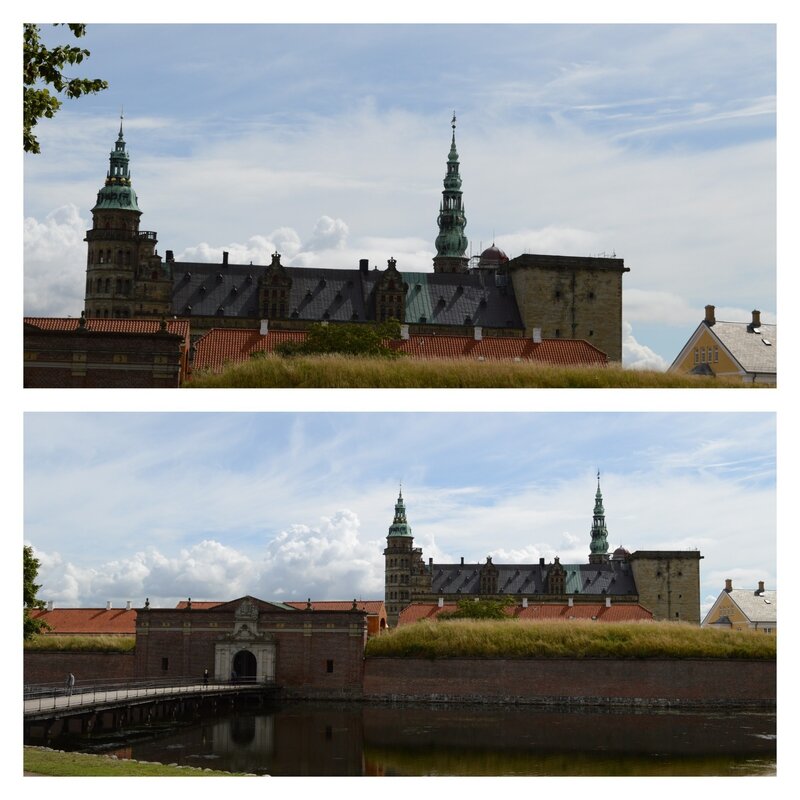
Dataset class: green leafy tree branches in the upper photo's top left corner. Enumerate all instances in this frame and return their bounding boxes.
[22,22,108,153]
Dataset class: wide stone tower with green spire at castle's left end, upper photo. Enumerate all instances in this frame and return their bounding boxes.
[84,118,172,318]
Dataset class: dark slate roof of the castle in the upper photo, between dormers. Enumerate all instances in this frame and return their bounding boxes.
[172,262,523,328]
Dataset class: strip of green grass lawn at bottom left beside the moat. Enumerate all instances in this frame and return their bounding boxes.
[22,747,247,778]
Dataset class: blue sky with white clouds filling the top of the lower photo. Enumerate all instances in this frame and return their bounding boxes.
[23,412,777,610]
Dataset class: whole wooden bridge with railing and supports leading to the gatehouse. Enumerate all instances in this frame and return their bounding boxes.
[23,680,278,742]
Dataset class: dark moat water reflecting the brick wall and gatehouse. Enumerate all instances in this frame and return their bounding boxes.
[42,702,777,776]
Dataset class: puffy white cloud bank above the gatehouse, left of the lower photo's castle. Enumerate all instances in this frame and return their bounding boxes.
[34,510,383,607]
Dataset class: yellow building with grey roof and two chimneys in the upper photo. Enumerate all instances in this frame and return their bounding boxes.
[669,306,778,385]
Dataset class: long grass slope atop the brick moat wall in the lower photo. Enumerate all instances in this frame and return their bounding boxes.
[366,620,777,659]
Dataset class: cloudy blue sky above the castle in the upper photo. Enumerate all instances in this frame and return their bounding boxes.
[23,16,776,368]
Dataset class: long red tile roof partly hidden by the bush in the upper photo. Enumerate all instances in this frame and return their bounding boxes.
[194,328,608,371]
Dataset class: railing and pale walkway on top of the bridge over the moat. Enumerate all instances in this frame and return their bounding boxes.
[23,678,275,713]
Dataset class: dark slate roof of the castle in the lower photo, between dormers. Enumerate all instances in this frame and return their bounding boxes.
[428,561,636,595]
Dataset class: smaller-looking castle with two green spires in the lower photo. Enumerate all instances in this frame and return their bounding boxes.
[383,473,702,627]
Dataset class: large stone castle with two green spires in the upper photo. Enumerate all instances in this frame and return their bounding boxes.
[84,115,628,361]
